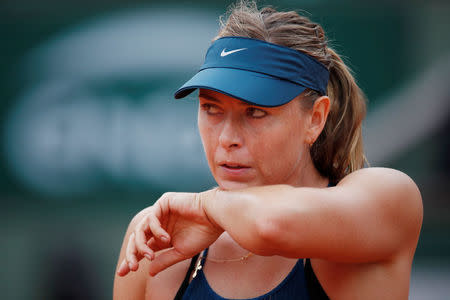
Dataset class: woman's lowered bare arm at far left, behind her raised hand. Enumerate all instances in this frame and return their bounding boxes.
[113,209,154,300]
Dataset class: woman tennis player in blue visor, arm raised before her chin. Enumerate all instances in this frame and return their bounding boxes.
[114,1,422,300]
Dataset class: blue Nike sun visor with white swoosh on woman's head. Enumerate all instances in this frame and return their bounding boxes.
[175,37,329,107]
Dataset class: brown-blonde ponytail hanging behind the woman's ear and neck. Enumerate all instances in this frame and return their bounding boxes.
[310,48,366,183]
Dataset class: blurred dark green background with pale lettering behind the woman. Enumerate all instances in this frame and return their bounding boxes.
[0,0,450,299]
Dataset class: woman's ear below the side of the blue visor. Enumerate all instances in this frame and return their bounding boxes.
[305,96,330,145]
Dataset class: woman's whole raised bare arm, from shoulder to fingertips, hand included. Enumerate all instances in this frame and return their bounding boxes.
[118,168,423,276]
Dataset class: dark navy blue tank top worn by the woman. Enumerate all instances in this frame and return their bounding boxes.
[183,249,310,300]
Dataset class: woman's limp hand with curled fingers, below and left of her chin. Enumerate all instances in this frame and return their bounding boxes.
[117,189,223,276]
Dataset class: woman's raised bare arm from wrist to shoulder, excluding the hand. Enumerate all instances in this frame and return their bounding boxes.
[201,168,423,263]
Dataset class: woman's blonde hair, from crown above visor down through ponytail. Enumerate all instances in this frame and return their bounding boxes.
[213,0,366,183]
